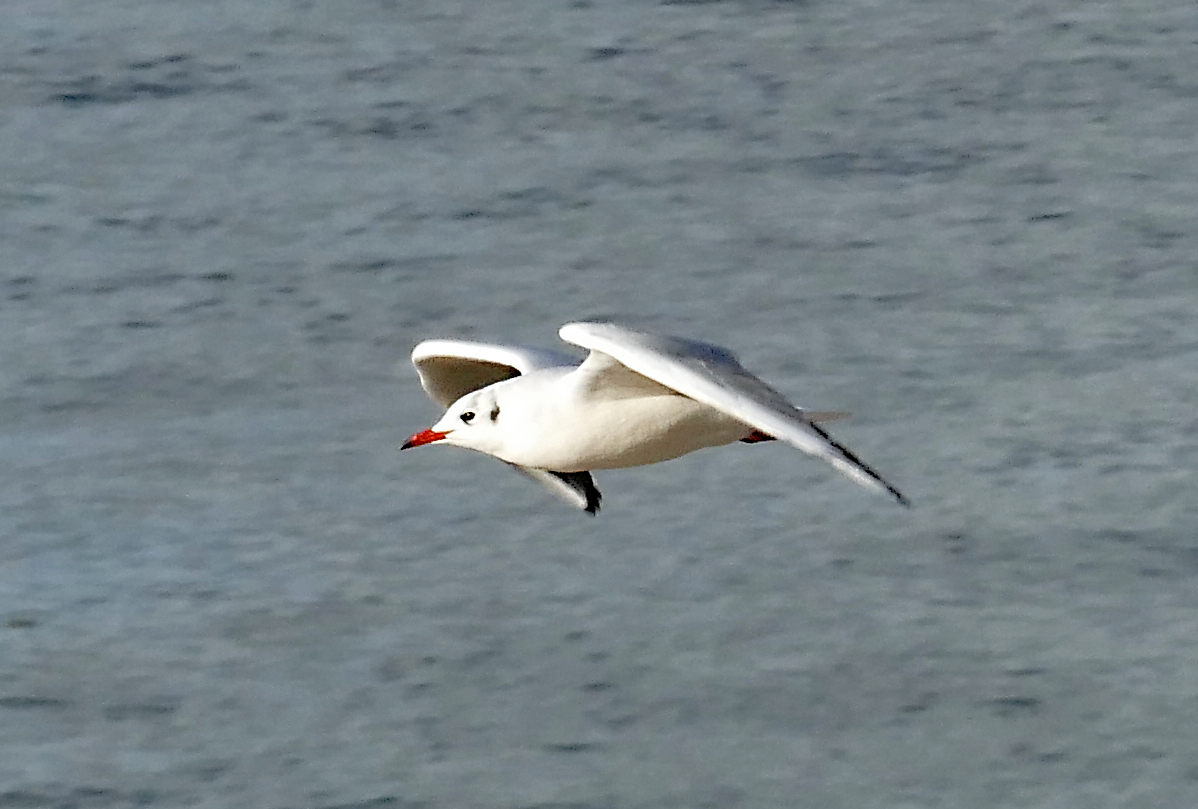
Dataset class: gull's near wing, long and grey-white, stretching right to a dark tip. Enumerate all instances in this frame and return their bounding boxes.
[558,322,908,506]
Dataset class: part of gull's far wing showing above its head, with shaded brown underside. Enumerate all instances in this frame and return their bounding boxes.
[412,340,579,407]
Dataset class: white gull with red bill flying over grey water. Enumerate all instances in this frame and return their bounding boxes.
[400,322,909,515]
